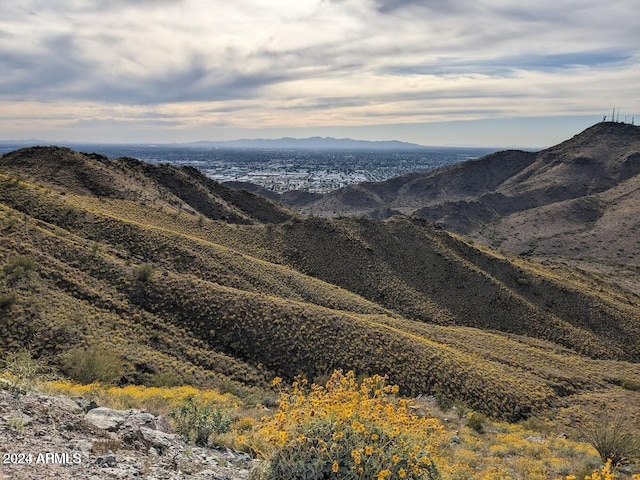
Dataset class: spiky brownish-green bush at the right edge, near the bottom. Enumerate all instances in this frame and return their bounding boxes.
[585,417,640,467]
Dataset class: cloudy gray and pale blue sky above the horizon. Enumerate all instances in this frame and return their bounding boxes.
[0,0,640,147]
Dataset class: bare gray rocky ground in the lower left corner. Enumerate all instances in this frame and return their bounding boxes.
[0,390,253,480]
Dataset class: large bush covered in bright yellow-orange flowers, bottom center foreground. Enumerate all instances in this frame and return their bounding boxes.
[246,371,443,480]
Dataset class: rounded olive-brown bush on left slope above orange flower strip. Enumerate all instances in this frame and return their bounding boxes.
[61,345,125,384]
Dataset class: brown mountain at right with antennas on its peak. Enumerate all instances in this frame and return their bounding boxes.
[296,122,640,274]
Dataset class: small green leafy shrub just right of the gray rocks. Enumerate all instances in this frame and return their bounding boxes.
[169,397,231,446]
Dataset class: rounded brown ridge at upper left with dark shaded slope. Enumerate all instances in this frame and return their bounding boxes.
[1,147,293,223]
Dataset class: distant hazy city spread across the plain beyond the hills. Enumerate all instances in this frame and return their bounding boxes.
[0,144,496,193]
